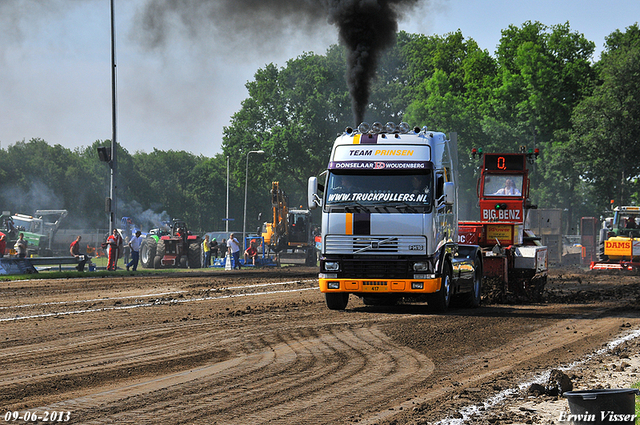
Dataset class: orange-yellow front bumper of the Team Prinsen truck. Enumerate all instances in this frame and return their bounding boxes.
[319,277,441,294]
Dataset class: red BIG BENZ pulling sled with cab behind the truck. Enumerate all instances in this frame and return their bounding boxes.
[458,148,548,300]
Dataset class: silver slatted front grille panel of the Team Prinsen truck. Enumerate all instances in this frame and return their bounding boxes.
[325,235,427,255]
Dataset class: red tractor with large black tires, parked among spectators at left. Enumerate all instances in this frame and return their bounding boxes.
[153,220,202,269]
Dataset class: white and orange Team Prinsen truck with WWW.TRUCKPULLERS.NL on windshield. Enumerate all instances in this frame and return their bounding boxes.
[308,123,483,312]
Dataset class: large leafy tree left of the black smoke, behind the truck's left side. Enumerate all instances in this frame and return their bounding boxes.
[223,46,351,217]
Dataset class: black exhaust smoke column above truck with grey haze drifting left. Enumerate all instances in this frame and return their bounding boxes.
[140,0,420,125]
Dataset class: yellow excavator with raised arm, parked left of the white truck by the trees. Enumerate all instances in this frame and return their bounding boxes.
[262,182,316,266]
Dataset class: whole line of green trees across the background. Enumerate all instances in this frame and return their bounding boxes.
[0,22,640,232]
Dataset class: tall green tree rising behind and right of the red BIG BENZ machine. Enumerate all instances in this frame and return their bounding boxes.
[486,21,595,229]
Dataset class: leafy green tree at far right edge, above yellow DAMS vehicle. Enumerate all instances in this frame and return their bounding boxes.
[571,24,640,209]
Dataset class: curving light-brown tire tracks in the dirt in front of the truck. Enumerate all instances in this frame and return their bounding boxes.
[37,325,434,424]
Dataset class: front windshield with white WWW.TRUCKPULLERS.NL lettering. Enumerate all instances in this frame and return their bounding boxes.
[326,173,433,212]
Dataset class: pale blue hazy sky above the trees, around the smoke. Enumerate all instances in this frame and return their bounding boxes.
[0,0,640,157]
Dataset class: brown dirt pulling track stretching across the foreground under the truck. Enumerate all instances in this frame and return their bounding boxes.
[0,267,640,424]
